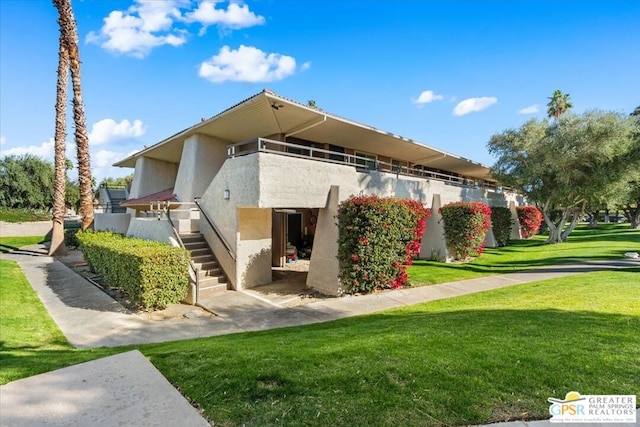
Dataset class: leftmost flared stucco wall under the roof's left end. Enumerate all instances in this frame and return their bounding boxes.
[129,157,178,199]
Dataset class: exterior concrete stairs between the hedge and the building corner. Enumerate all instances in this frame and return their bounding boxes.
[180,232,227,302]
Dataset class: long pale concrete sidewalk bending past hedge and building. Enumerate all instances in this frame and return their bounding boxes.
[2,245,640,348]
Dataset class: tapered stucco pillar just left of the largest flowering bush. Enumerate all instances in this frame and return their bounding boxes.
[307,185,342,295]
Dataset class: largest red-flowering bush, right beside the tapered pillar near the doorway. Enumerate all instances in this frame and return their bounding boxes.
[338,196,431,293]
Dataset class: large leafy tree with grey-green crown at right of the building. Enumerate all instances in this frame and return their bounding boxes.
[488,111,640,243]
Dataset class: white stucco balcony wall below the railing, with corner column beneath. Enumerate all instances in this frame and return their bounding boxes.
[200,153,515,289]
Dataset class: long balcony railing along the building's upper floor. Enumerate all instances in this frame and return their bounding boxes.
[227,138,502,191]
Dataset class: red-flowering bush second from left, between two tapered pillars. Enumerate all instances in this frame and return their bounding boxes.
[440,202,491,260]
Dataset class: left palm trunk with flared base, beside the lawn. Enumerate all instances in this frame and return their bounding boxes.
[49,33,69,256]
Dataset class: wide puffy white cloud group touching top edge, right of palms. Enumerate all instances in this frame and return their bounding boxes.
[86,0,265,58]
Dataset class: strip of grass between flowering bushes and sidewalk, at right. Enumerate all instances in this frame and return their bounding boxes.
[407,223,640,286]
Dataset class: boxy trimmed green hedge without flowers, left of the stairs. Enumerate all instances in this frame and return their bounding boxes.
[76,231,189,310]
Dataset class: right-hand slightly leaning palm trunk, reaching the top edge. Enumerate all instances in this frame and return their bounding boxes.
[53,0,93,231]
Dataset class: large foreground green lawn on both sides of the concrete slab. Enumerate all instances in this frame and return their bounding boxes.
[0,230,640,426]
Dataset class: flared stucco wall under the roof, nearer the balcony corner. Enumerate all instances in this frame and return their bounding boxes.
[174,134,227,206]
